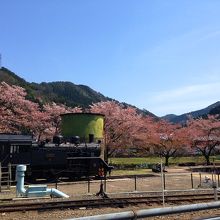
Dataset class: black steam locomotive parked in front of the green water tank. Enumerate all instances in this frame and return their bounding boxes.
[0,115,112,181]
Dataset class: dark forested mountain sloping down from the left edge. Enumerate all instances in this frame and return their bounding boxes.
[0,67,154,116]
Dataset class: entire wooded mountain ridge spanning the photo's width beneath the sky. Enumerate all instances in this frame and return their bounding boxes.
[0,67,220,120]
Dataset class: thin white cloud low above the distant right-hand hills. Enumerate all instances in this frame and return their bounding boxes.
[135,81,220,116]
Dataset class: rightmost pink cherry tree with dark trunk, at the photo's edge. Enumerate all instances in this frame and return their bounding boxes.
[187,115,220,165]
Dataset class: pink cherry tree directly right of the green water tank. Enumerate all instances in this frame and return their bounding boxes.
[90,101,144,159]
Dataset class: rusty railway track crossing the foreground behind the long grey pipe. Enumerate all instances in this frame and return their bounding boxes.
[0,193,217,213]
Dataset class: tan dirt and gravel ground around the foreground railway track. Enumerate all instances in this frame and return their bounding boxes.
[0,169,220,220]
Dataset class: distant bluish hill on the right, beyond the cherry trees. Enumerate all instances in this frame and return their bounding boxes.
[162,101,220,123]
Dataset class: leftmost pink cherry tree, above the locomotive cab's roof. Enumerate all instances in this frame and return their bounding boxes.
[0,82,42,133]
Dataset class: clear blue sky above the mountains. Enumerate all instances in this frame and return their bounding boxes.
[0,0,220,116]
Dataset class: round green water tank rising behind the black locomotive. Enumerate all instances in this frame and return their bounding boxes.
[61,113,104,142]
